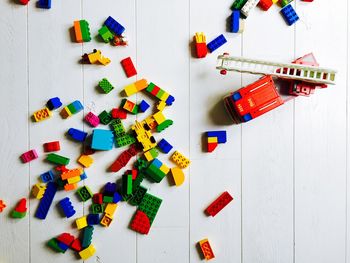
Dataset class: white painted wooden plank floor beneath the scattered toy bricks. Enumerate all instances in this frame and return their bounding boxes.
[0,0,350,263]
